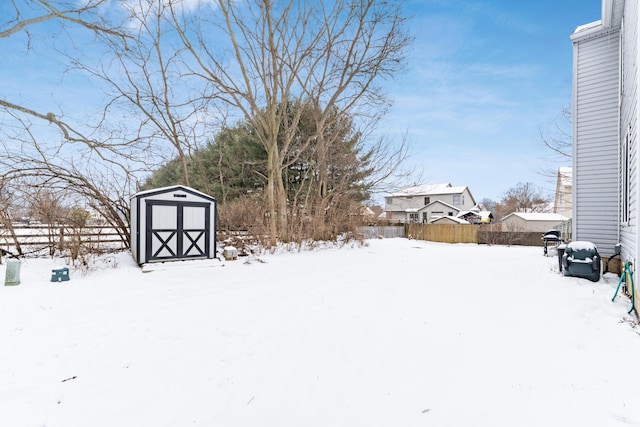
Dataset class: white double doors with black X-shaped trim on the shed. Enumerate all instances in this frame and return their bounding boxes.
[145,200,211,262]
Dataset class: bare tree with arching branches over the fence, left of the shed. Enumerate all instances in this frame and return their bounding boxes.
[0,118,135,249]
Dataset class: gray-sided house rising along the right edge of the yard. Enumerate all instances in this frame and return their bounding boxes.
[571,0,640,261]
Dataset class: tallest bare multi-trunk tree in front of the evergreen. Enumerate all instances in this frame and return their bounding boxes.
[155,0,410,243]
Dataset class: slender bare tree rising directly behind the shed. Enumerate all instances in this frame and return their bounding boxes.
[75,0,216,185]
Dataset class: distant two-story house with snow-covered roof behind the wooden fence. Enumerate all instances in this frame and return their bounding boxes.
[384,184,477,223]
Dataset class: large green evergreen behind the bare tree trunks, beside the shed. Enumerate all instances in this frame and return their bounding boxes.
[143,103,374,239]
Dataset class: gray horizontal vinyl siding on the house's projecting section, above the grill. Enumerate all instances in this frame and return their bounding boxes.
[573,29,619,256]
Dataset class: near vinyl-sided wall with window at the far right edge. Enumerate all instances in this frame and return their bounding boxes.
[619,1,640,265]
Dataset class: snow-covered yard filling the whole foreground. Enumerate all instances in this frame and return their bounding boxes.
[0,239,640,427]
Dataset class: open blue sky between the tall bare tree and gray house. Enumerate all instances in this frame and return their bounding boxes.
[382,0,601,201]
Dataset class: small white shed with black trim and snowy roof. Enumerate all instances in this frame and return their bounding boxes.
[130,185,216,265]
